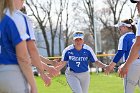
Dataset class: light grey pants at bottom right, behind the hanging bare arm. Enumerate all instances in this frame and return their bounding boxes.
[124,60,140,93]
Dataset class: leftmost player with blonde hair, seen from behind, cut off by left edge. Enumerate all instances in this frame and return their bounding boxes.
[0,0,37,93]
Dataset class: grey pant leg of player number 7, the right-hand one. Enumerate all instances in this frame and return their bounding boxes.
[77,72,90,93]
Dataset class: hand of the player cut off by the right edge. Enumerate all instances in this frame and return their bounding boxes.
[118,64,128,78]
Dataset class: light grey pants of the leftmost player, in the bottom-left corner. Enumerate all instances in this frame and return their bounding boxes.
[0,65,29,93]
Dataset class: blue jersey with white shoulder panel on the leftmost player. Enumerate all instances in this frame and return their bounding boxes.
[0,9,29,65]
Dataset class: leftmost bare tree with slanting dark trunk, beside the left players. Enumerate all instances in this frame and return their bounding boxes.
[26,0,51,56]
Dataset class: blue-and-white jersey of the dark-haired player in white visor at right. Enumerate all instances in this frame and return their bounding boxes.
[113,32,135,63]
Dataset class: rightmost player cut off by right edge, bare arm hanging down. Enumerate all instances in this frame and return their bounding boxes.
[119,0,140,93]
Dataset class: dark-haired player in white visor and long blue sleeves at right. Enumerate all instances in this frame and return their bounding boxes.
[105,19,140,93]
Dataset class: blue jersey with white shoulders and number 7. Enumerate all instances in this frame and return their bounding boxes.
[62,44,98,73]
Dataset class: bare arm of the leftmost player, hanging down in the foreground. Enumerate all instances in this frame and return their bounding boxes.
[16,41,37,93]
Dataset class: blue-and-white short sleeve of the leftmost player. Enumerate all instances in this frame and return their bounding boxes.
[5,15,29,46]
